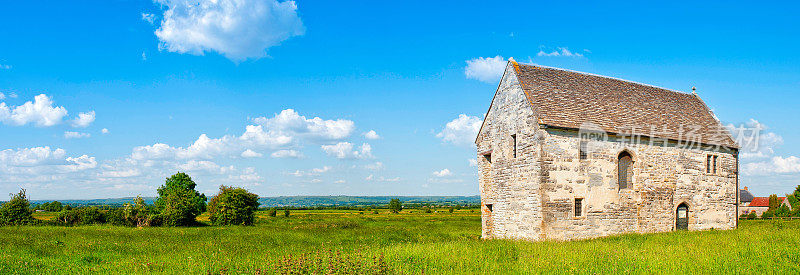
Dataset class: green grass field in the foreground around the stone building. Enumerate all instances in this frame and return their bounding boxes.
[0,210,800,274]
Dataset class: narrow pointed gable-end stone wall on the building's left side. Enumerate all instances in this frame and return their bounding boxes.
[477,63,541,242]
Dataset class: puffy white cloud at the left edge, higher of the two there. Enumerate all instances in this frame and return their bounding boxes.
[0,94,67,127]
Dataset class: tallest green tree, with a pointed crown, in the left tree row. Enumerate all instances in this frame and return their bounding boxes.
[155,172,206,226]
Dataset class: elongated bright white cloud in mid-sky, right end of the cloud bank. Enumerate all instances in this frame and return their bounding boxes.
[253,109,355,141]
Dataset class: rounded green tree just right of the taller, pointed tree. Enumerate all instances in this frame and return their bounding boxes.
[208,185,259,225]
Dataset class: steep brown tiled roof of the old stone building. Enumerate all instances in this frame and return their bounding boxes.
[512,61,738,148]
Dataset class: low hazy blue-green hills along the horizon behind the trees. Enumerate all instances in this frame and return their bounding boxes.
[26,195,481,208]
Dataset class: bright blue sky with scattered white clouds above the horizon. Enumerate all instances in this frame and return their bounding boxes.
[0,0,800,199]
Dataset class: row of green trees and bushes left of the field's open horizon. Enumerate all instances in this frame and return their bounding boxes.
[0,172,259,227]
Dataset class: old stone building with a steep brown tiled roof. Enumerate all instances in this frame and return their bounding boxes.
[475,59,739,240]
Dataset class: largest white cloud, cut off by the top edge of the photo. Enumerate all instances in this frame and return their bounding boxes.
[155,0,305,61]
